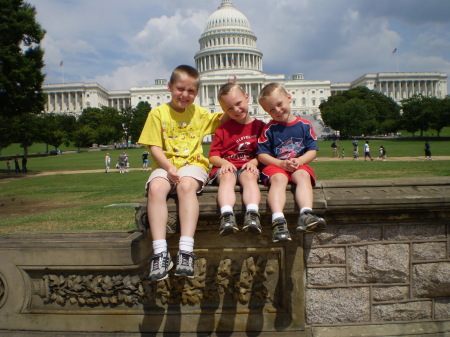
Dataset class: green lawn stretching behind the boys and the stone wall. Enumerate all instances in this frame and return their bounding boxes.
[0,140,450,235]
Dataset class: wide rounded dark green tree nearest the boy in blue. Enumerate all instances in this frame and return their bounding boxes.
[319,87,400,136]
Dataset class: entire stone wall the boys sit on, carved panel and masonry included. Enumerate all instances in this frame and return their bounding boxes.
[0,178,450,337]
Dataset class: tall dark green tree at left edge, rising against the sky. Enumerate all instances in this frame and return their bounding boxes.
[0,0,45,117]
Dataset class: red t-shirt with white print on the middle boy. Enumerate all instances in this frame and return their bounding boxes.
[209,119,265,177]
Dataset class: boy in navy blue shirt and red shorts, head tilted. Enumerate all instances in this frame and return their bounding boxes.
[257,83,326,242]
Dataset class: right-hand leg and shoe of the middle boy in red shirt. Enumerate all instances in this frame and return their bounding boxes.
[239,171,262,234]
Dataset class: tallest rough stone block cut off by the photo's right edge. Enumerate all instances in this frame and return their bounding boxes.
[412,262,450,297]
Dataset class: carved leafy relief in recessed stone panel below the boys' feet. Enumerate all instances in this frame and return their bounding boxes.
[32,254,279,307]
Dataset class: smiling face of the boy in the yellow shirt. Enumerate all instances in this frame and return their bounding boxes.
[168,74,198,112]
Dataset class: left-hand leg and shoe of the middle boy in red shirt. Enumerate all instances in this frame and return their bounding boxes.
[217,172,239,235]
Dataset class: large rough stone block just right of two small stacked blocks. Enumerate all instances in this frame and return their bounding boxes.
[348,244,409,283]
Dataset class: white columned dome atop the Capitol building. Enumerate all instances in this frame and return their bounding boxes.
[194,0,262,74]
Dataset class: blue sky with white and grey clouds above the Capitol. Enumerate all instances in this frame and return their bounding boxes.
[27,0,450,90]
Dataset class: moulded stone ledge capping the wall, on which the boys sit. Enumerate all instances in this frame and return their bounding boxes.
[136,177,450,233]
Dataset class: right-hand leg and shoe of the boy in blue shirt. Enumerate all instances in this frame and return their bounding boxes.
[292,169,326,233]
